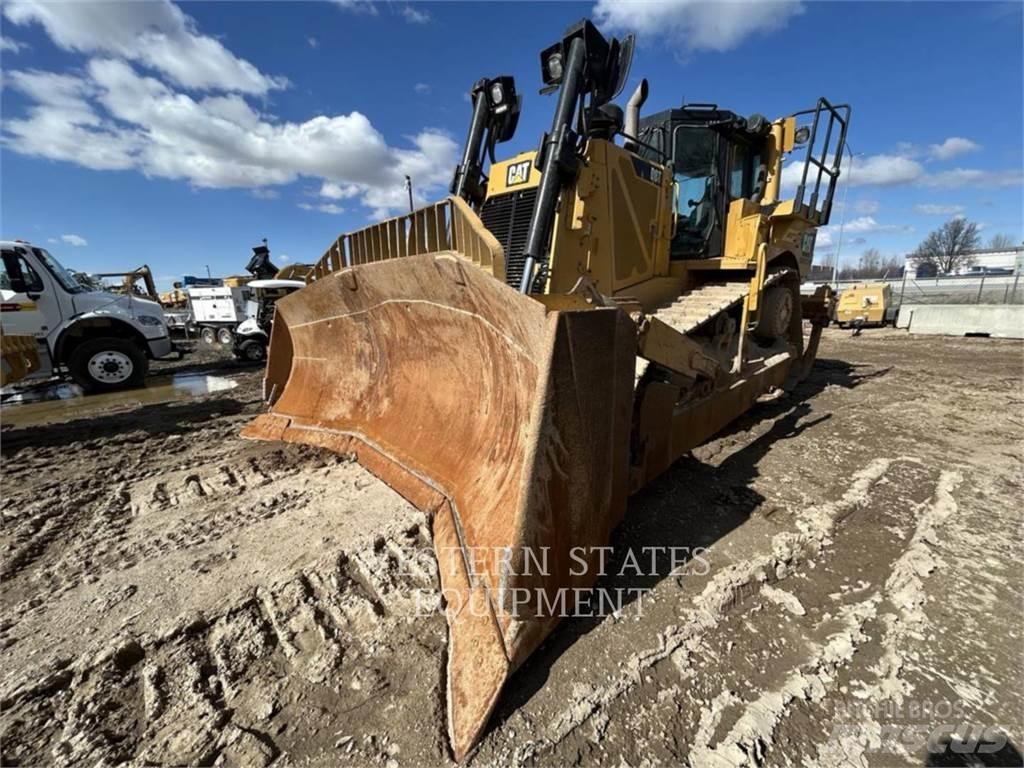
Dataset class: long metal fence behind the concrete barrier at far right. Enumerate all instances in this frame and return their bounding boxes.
[834,274,1024,304]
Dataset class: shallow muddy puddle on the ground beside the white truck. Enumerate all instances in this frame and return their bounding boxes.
[0,374,238,427]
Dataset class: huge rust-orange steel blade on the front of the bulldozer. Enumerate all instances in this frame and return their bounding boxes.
[243,252,636,760]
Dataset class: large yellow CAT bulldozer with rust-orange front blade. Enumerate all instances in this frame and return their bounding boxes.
[244,19,850,760]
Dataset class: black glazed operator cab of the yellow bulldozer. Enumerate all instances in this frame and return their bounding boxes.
[639,104,771,259]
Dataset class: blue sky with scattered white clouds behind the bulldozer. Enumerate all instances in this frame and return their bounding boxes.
[0,0,1024,286]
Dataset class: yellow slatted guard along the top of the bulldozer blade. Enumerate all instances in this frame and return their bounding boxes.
[306,197,505,284]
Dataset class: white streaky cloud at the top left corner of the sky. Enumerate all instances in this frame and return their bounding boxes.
[3,0,288,94]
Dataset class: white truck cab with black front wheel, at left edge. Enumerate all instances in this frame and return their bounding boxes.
[0,240,174,392]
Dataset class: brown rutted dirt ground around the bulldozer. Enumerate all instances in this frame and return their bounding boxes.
[0,331,1024,766]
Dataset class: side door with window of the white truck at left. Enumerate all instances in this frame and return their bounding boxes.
[0,248,60,340]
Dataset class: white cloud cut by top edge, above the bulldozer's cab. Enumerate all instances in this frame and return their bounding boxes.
[592,0,803,51]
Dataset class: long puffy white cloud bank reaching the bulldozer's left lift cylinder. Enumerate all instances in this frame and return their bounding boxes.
[3,58,458,215]
